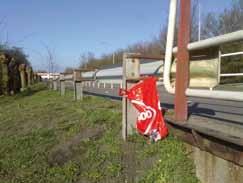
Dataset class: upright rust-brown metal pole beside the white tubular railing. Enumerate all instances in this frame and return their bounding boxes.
[175,0,191,121]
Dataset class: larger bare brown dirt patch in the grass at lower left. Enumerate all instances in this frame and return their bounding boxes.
[48,127,104,166]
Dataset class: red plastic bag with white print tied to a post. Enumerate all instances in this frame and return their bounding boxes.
[120,77,168,141]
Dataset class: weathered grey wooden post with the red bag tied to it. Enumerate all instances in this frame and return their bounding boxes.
[122,53,140,140]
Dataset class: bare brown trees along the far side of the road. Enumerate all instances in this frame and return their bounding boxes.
[77,0,243,82]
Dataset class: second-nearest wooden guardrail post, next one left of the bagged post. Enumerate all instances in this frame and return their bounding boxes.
[73,70,83,100]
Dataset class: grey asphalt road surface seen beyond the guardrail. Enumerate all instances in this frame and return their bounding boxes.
[84,86,243,127]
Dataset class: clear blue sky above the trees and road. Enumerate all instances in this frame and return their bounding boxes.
[0,0,232,71]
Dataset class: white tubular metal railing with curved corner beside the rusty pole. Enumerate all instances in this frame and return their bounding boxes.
[163,0,243,101]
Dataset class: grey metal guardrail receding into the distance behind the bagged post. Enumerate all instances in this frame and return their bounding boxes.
[53,59,163,95]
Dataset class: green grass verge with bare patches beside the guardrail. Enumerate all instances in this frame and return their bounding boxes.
[0,85,198,183]
